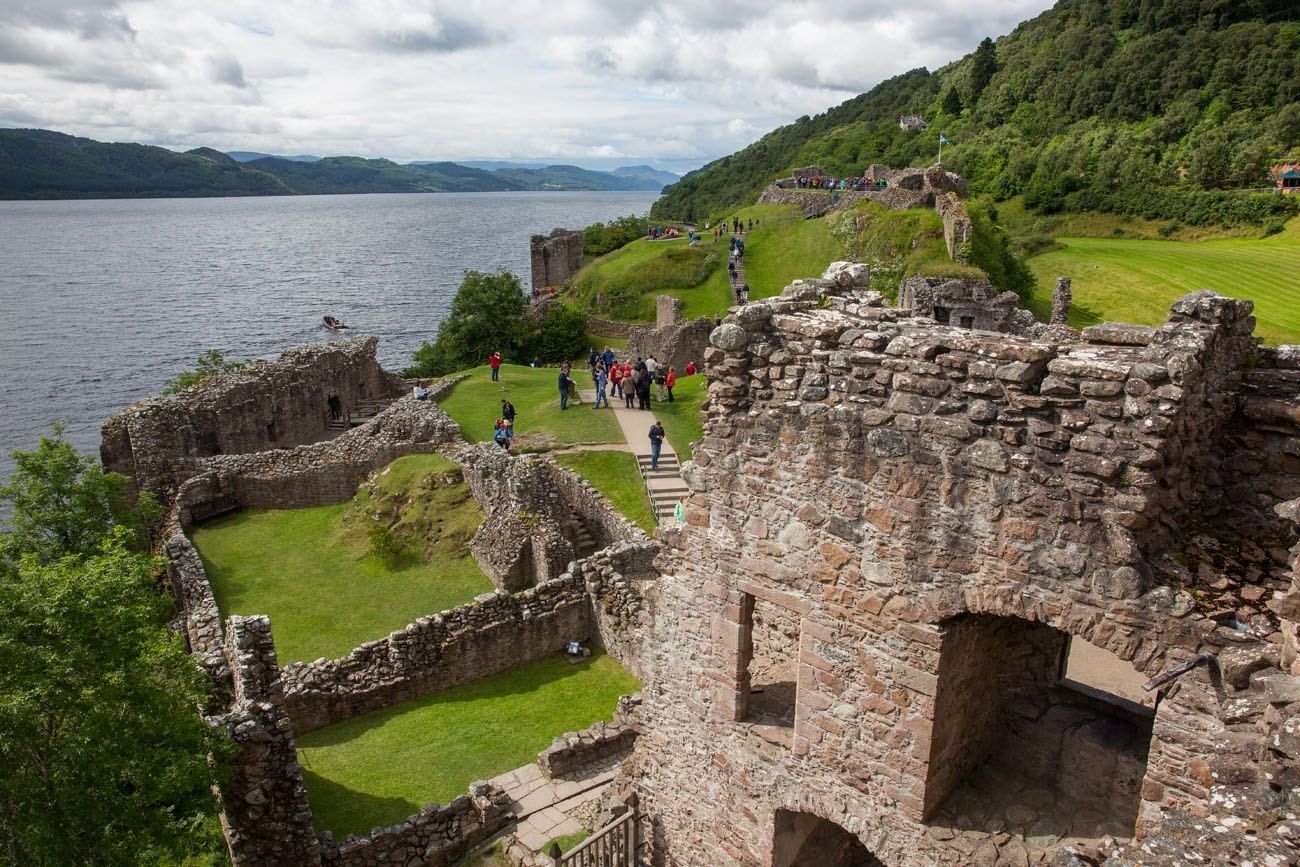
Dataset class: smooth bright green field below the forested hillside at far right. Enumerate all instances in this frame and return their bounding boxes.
[1028,220,1300,343]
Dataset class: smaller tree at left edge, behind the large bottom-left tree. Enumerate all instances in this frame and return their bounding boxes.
[0,424,159,565]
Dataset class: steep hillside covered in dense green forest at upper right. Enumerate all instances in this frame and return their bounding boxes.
[653,0,1300,225]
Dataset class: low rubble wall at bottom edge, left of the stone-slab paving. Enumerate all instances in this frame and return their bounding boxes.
[320,781,514,867]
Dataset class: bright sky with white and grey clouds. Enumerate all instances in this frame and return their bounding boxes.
[0,0,1050,172]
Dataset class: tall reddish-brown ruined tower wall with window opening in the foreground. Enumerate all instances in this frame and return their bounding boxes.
[611,281,1294,867]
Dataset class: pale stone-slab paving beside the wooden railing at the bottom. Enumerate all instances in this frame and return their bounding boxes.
[490,757,623,851]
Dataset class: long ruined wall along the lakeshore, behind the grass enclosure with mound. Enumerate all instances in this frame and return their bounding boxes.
[100,337,400,502]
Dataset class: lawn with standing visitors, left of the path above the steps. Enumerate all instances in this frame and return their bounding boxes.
[438,363,623,451]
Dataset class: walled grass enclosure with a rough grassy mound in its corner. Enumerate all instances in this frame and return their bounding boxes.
[190,455,493,664]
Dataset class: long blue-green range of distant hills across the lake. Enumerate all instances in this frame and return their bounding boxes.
[0,129,663,199]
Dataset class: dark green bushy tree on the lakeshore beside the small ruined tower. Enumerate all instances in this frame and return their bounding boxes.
[403,269,528,377]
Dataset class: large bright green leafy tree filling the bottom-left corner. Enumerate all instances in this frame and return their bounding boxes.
[0,529,229,866]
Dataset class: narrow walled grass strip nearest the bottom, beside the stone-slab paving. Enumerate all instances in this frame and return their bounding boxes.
[298,651,641,838]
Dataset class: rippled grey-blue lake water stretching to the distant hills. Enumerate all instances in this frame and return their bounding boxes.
[0,192,658,480]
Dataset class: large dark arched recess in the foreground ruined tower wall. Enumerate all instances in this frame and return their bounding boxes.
[924,615,1154,861]
